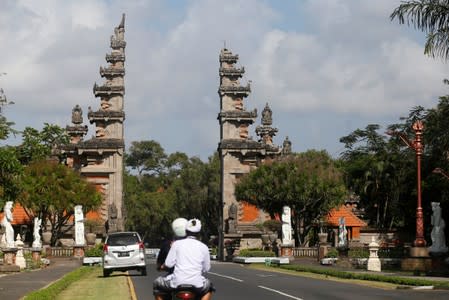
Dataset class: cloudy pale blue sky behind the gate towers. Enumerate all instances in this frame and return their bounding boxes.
[0,0,448,160]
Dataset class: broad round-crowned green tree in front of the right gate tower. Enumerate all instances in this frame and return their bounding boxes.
[235,150,347,244]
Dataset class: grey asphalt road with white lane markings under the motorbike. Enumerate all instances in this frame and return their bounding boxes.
[130,261,449,300]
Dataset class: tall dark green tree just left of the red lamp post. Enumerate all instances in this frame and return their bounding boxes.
[340,124,414,229]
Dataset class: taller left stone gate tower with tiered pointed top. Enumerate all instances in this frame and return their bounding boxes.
[62,14,126,232]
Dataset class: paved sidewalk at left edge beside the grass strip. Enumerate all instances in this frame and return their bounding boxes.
[0,257,81,300]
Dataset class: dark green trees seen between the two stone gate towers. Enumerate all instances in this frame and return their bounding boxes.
[124,141,220,247]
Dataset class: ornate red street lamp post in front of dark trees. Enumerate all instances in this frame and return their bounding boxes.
[387,120,426,247]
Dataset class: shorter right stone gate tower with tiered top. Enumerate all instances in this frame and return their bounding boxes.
[218,49,281,257]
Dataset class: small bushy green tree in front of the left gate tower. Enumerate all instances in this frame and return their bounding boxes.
[19,160,102,245]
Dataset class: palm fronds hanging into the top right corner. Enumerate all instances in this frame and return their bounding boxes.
[390,0,449,60]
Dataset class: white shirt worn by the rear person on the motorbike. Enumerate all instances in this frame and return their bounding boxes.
[165,237,210,288]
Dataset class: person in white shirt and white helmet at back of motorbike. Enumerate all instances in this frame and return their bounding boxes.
[153,219,214,300]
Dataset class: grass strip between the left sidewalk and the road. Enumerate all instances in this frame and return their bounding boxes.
[24,267,131,300]
